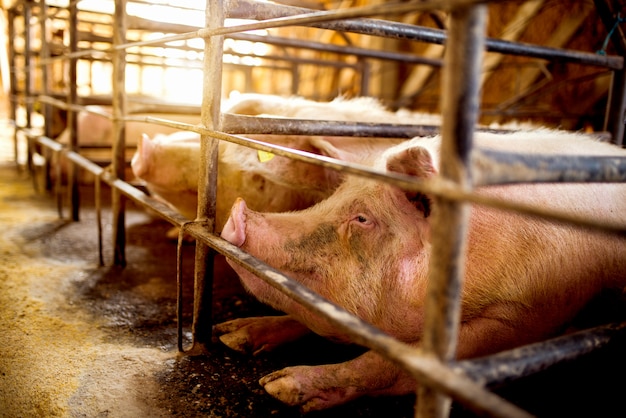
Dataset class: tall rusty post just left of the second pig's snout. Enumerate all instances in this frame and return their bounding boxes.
[111,0,126,266]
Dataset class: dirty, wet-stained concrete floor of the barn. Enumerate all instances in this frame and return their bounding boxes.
[0,121,626,418]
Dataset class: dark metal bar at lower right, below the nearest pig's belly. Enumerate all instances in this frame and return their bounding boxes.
[453,322,626,388]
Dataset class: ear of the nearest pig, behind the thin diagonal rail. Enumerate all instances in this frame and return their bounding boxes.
[387,147,437,218]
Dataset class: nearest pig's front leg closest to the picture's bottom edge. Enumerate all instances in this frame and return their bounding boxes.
[259,351,416,412]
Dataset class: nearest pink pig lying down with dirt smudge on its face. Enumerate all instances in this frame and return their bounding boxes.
[215,130,626,412]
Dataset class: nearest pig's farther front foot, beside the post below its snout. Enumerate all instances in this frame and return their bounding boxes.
[214,315,311,355]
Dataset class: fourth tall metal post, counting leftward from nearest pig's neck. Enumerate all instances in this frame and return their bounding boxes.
[67,1,80,221]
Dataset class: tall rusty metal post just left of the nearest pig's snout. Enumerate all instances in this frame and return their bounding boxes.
[191,0,224,354]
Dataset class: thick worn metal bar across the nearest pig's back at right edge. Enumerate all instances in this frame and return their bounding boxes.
[472,148,626,186]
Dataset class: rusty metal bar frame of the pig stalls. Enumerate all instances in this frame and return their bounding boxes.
[9,0,626,417]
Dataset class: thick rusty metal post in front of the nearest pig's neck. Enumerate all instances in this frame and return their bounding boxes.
[416,5,486,417]
